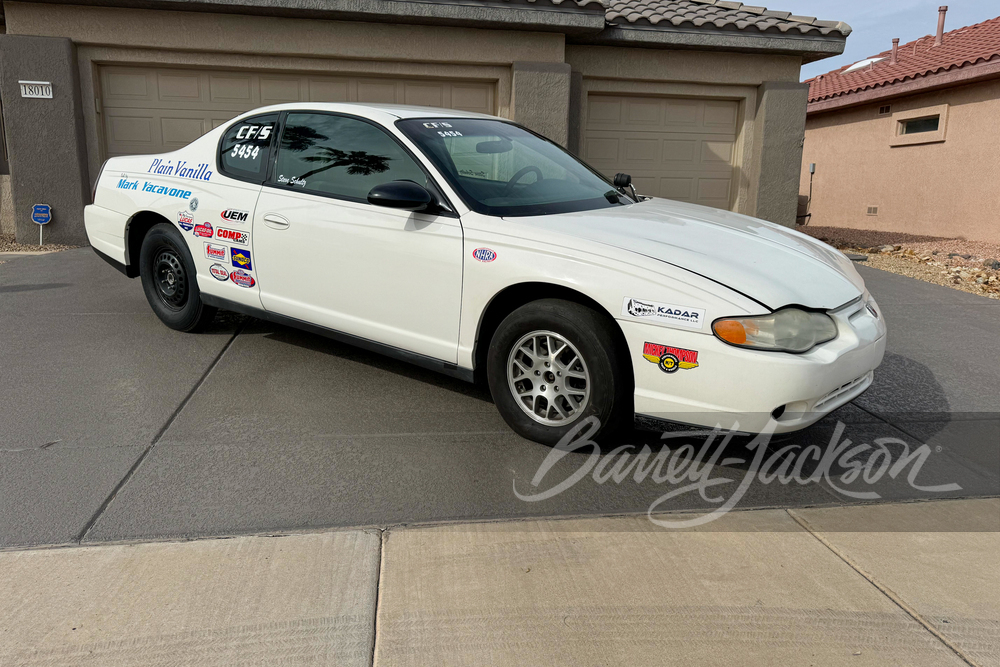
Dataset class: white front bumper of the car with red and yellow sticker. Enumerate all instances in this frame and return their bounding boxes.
[619,295,886,433]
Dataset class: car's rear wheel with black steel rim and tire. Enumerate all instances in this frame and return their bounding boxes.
[139,223,216,332]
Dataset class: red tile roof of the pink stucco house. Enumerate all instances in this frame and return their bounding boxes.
[806,17,1000,102]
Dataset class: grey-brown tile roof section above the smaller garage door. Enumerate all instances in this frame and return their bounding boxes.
[607,0,851,37]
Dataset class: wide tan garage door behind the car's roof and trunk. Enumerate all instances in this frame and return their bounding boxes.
[101,67,495,157]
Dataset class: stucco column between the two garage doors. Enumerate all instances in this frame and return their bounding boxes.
[510,62,571,146]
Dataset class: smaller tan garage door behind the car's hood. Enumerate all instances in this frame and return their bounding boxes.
[583,95,739,209]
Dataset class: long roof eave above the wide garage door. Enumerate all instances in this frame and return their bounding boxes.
[9,0,604,35]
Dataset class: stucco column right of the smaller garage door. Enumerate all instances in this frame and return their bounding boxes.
[748,81,809,227]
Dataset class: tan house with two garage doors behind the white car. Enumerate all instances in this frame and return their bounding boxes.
[0,0,850,243]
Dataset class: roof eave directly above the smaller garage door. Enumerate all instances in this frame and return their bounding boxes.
[570,25,847,63]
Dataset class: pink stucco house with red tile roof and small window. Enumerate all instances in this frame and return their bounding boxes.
[799,7,1000,243]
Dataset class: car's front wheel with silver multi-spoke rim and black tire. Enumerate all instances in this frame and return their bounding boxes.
[486,299,632,445]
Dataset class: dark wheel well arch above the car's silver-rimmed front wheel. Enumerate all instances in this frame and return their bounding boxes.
[473,283,635,386]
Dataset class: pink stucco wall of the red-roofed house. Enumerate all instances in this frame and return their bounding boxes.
[799,79,1000,242]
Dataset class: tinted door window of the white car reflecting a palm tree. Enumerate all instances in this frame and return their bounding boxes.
[271,113,427,201]
